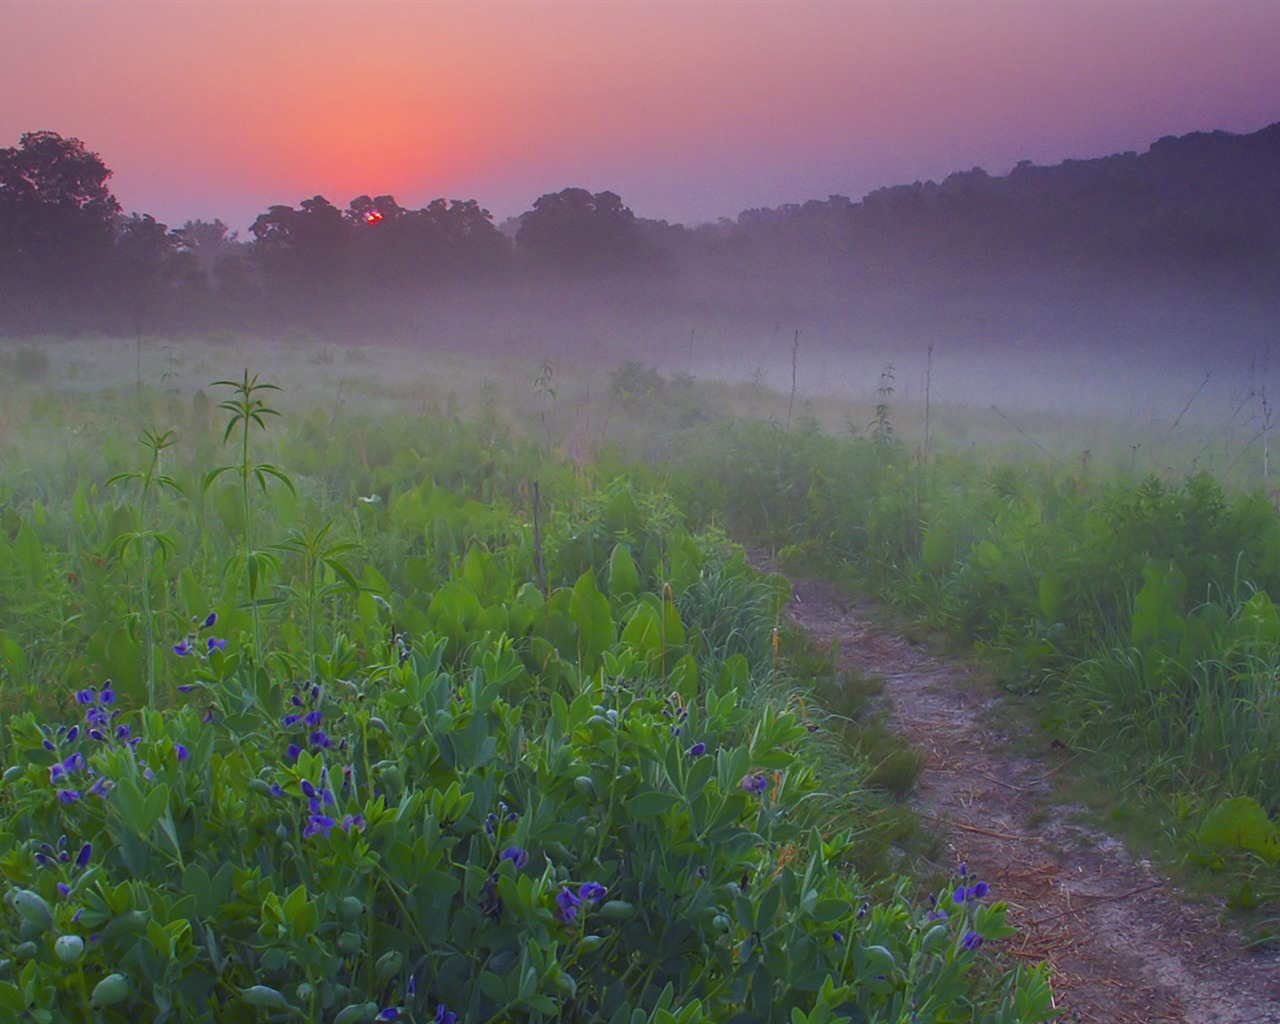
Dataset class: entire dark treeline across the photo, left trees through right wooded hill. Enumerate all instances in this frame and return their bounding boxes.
[0,124,1280,334]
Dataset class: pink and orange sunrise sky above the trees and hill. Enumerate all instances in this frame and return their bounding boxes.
[0,0,1280,230]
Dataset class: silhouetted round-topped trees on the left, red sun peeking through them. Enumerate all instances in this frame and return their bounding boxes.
[0,132,655,334]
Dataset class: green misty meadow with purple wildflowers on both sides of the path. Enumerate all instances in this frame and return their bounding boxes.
[0,337,1280,1024]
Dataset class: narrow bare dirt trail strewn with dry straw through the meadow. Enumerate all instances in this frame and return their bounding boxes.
[773,570,1280,1024]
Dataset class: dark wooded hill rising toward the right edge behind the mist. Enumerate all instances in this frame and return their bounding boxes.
[721,123,1280,289]
